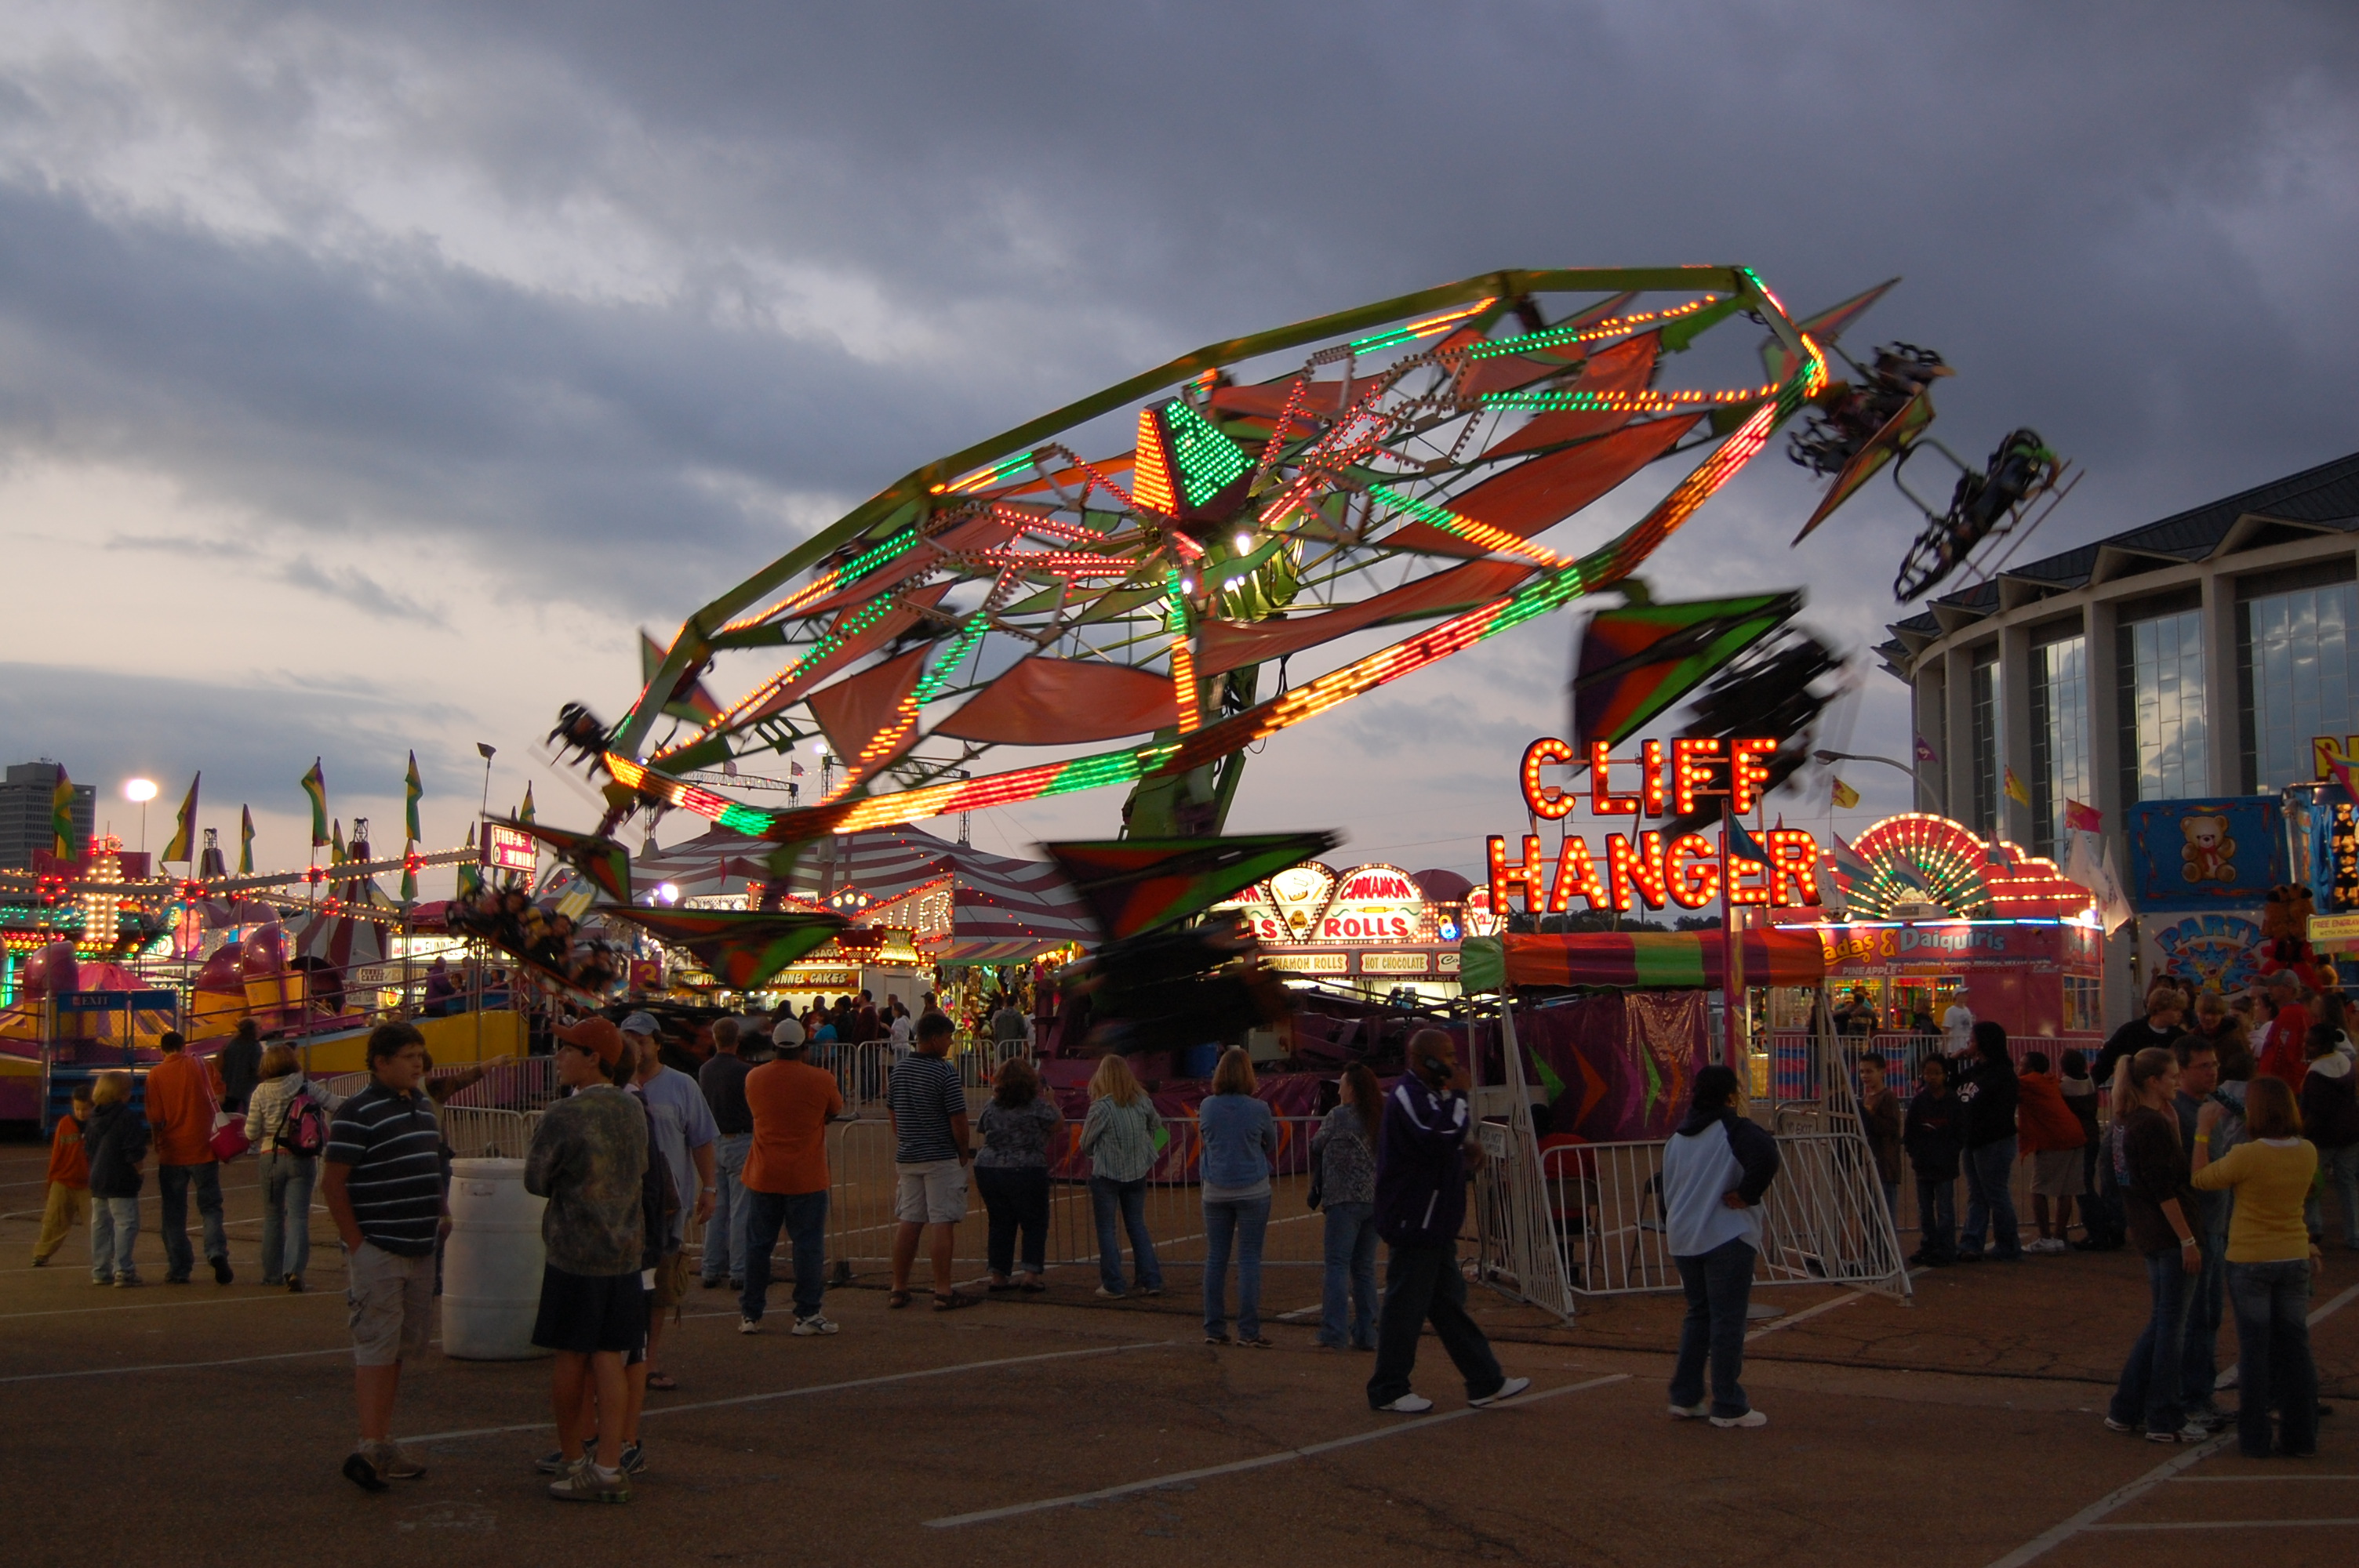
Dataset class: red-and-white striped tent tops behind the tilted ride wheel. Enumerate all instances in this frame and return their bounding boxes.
[630,828,1100,964]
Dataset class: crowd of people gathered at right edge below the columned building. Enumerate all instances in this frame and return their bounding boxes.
[1837,971,2359,1457]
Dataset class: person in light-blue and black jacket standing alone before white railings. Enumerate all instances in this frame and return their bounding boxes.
[1661,1065,1779,1427]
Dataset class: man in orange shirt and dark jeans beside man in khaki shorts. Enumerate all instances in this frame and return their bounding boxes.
[739,1018,845,1334]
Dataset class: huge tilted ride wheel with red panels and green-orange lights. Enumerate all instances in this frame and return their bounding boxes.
[570,267,1840,862]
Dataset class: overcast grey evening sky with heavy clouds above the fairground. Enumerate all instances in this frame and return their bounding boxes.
[0,0,2359,870]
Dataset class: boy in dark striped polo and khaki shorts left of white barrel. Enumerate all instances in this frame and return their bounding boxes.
[318,1023,444,1493]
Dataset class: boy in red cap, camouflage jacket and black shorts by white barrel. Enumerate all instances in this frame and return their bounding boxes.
[524,1016,649,1502]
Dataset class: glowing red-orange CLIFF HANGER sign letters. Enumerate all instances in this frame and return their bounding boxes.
[1488,735,1819,915]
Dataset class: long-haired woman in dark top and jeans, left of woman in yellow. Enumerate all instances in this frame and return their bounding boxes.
[2104,1044,2210,1443]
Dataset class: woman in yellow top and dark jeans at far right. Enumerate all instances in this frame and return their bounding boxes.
[2194,1075,2319,1460]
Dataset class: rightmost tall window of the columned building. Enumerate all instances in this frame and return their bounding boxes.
[2237,566,2359,793]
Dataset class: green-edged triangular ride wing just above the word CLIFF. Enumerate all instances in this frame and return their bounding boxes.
[1573,594,1802,745]
